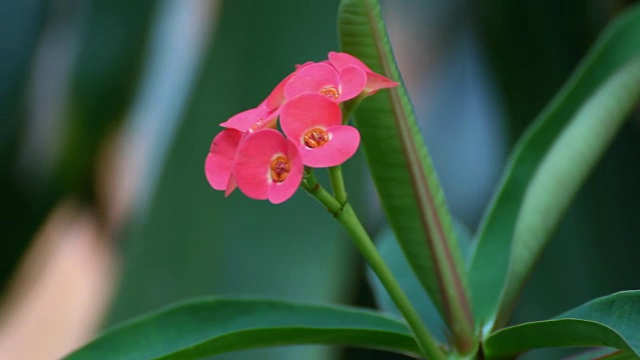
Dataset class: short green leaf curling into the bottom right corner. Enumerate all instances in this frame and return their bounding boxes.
[484,291,640,359]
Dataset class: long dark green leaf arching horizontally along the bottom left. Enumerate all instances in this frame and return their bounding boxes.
[67,298,419,360]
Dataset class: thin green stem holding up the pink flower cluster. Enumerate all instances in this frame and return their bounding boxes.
[302,171,446,360]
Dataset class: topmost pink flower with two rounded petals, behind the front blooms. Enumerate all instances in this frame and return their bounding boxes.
[284,62,367,102]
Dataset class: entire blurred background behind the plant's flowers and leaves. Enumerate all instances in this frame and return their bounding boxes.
[0,0,640,360]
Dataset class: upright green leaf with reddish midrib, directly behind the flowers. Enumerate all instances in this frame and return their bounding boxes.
[338,0,474,350]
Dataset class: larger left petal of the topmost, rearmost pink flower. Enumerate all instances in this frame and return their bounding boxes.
[284,63,340,99]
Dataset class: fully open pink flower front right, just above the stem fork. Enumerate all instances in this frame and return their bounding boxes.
[280,93,360,167]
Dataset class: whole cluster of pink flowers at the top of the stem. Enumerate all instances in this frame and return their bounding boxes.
[205,52,398,204]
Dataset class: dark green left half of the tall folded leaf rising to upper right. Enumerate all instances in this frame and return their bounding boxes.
[469,2,640,329]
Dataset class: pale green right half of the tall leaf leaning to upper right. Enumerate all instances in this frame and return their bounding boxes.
[498,56,640,323]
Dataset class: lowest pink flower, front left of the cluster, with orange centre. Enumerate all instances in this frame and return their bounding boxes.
[233,129,304,204]
